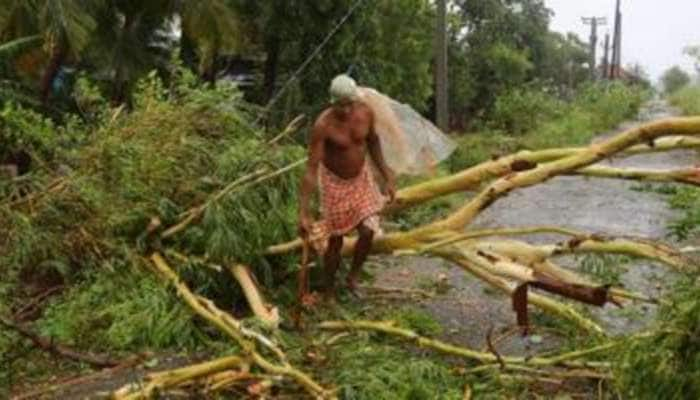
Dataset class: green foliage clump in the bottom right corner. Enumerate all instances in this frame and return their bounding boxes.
[613,277,700,399]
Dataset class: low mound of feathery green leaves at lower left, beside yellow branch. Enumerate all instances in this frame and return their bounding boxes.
[38,265,206,351]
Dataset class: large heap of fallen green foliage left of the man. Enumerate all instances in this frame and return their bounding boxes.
[0,71,304,360]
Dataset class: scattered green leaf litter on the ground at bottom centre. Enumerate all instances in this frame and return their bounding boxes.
[285,301,526,400]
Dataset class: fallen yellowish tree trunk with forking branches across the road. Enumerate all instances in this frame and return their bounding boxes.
[267,117,700,334]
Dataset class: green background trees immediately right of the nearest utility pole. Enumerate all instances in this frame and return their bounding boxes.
[448,0,588,130]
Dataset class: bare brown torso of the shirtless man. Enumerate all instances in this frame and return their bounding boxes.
[319,102,372,179]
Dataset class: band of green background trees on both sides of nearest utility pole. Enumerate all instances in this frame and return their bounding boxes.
[0,0,644,128]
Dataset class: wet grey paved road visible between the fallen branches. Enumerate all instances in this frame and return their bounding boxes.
[377,102,696,353]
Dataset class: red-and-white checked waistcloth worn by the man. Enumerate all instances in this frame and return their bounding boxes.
[309,162,386,254]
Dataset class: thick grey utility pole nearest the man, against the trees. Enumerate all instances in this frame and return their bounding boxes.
[435,0,450,133]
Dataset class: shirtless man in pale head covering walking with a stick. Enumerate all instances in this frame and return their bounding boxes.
[299,75,396,298]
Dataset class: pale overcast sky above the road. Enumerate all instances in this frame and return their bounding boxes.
[545,0,700,80]
